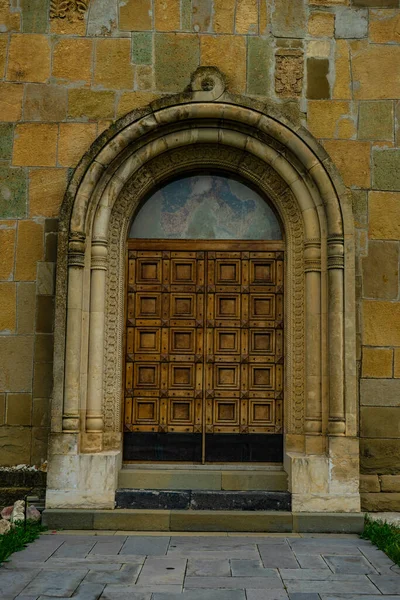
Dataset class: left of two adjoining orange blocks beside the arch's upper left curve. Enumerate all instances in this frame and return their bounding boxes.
[13,123,58,167]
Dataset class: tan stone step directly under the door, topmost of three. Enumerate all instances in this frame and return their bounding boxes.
[118,466,288,492]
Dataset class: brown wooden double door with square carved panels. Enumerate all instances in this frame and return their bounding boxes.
[124,240,284,463]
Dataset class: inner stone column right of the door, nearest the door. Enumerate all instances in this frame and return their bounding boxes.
[304,239,322,435]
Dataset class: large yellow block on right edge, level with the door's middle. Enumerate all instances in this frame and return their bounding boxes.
[363,300,400,346]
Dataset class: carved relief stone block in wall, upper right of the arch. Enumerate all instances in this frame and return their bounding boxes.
[275,48,304,98]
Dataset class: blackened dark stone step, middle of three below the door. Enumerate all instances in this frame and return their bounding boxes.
[115,489,291,511]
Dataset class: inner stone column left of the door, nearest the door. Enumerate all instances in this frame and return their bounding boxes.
[86,238,107,433]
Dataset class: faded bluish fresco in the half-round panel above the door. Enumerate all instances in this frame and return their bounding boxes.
[129,175,282,240]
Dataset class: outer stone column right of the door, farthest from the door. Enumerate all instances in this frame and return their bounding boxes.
[328,235,346,435]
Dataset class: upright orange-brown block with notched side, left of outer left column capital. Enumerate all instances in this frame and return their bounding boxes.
[15,221,43,281]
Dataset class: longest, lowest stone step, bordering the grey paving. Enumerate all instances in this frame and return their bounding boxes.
[43,508,364,533]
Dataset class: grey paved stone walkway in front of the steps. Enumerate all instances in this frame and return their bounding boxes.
[0,532,400,600]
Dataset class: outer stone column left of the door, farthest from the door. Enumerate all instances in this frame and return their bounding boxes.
[62,232,85,432]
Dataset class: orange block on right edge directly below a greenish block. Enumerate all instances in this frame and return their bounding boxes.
[368,192,400,239]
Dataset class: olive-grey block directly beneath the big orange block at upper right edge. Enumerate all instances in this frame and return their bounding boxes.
[358,100,394,141]
